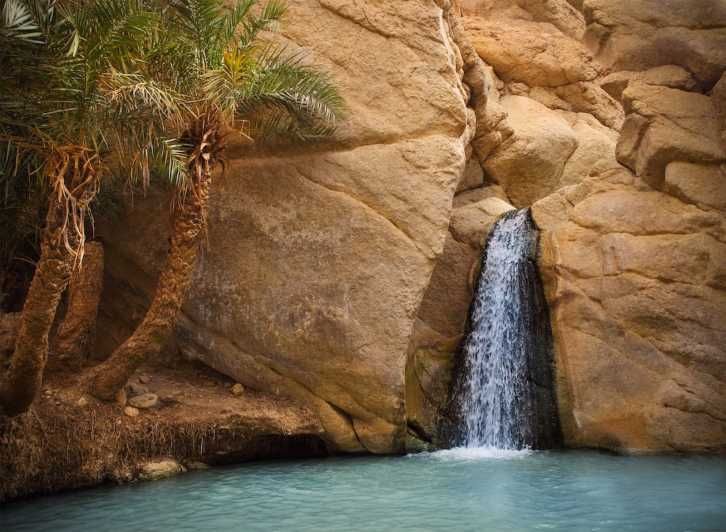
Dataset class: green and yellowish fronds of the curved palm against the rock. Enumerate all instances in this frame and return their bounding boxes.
[157,0,344,142]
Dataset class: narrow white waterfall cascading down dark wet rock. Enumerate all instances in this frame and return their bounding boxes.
[444,209,560,449]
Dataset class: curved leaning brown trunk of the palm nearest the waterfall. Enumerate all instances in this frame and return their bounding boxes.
[89,115,224,401]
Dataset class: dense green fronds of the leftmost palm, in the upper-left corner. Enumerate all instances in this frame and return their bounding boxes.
[0,0,191,183]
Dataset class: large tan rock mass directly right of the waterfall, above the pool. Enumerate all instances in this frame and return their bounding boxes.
[533,170,726,451]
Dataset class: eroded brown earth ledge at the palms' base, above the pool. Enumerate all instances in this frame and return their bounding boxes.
[0,364,327,502]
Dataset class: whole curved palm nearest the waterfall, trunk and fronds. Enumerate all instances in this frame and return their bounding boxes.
[86,0,343,400]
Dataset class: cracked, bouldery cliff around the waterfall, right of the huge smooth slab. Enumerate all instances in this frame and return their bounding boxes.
[409,0,726,452]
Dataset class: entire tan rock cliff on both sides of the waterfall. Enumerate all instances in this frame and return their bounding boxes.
[101,0,726,453]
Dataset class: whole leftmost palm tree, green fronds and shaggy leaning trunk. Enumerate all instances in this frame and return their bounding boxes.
[0,0,186,415]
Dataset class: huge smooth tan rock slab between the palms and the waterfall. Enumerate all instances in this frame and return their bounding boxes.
[98,0,473,458]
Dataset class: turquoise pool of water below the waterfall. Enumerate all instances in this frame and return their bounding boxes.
[0,449,726,532]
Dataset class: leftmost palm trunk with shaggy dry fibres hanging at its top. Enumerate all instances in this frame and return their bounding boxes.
[0,147,98,416]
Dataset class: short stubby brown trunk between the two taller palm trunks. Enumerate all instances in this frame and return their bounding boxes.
[51,242,103,369]
